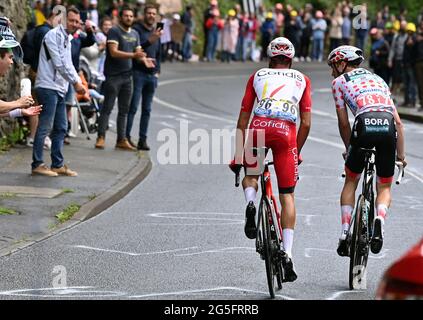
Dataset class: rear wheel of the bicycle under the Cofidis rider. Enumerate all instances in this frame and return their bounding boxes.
[259,199,275,299]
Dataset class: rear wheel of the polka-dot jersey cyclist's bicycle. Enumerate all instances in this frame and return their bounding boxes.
[349,195,369,290]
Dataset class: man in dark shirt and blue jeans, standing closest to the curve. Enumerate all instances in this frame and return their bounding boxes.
[126,5,162,151]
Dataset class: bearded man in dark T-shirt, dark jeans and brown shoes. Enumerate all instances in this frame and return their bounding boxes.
[95,7,147,151]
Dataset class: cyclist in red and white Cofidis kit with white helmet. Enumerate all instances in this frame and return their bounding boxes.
[230,37,311,282]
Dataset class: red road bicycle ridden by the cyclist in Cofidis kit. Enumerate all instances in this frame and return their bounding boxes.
[234,147,286,299]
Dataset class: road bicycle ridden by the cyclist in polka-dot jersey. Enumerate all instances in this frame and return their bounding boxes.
[343,148,404,290]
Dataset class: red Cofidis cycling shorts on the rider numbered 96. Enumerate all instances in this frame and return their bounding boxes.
[244,116,298,194]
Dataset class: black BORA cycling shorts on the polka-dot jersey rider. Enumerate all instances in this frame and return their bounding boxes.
[345,112,397,183]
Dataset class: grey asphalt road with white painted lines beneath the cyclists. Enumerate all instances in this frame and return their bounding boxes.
[0,63,423,300]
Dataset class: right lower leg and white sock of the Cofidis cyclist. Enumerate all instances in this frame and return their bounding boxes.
[279,193,296,257]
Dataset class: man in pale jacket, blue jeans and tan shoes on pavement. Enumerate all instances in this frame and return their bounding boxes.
[31,9,85,177]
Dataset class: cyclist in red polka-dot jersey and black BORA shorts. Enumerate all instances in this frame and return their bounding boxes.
[328,46,407,256]
